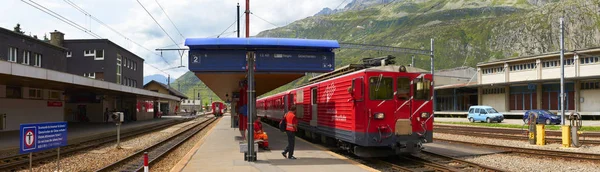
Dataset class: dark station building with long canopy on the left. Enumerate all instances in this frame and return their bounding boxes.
[0,28,181,131]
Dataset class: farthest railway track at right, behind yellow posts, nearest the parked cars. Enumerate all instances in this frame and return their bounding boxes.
[434,126,600,145]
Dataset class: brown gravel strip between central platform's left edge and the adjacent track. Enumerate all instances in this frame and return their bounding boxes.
[150,119,220,171]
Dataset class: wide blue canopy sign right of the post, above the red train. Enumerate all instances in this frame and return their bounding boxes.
[256,51,335,72]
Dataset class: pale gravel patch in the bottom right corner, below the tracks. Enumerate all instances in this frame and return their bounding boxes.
[465,154,600,172]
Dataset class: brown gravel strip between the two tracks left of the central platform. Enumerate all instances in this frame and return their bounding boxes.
[20,117,206,171]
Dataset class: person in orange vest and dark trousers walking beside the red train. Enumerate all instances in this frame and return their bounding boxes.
[281,106,298,159]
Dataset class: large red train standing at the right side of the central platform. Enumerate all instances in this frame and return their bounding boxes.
[256,56,433,157]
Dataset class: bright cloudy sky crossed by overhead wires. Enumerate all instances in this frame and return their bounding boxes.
[0,0,351,78]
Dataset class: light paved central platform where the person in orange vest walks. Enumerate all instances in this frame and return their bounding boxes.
[171,116,378,172]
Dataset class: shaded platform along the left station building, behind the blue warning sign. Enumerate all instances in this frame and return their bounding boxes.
[0,117,195,152]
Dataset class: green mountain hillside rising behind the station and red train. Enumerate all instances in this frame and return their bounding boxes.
[172,0,600,98]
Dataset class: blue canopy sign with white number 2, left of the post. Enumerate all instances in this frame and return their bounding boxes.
[189,50,246,72]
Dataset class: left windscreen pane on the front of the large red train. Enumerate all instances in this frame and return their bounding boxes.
[369,76,394,100]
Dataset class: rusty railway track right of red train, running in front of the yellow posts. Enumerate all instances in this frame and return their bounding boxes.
[435,138,600,163]
